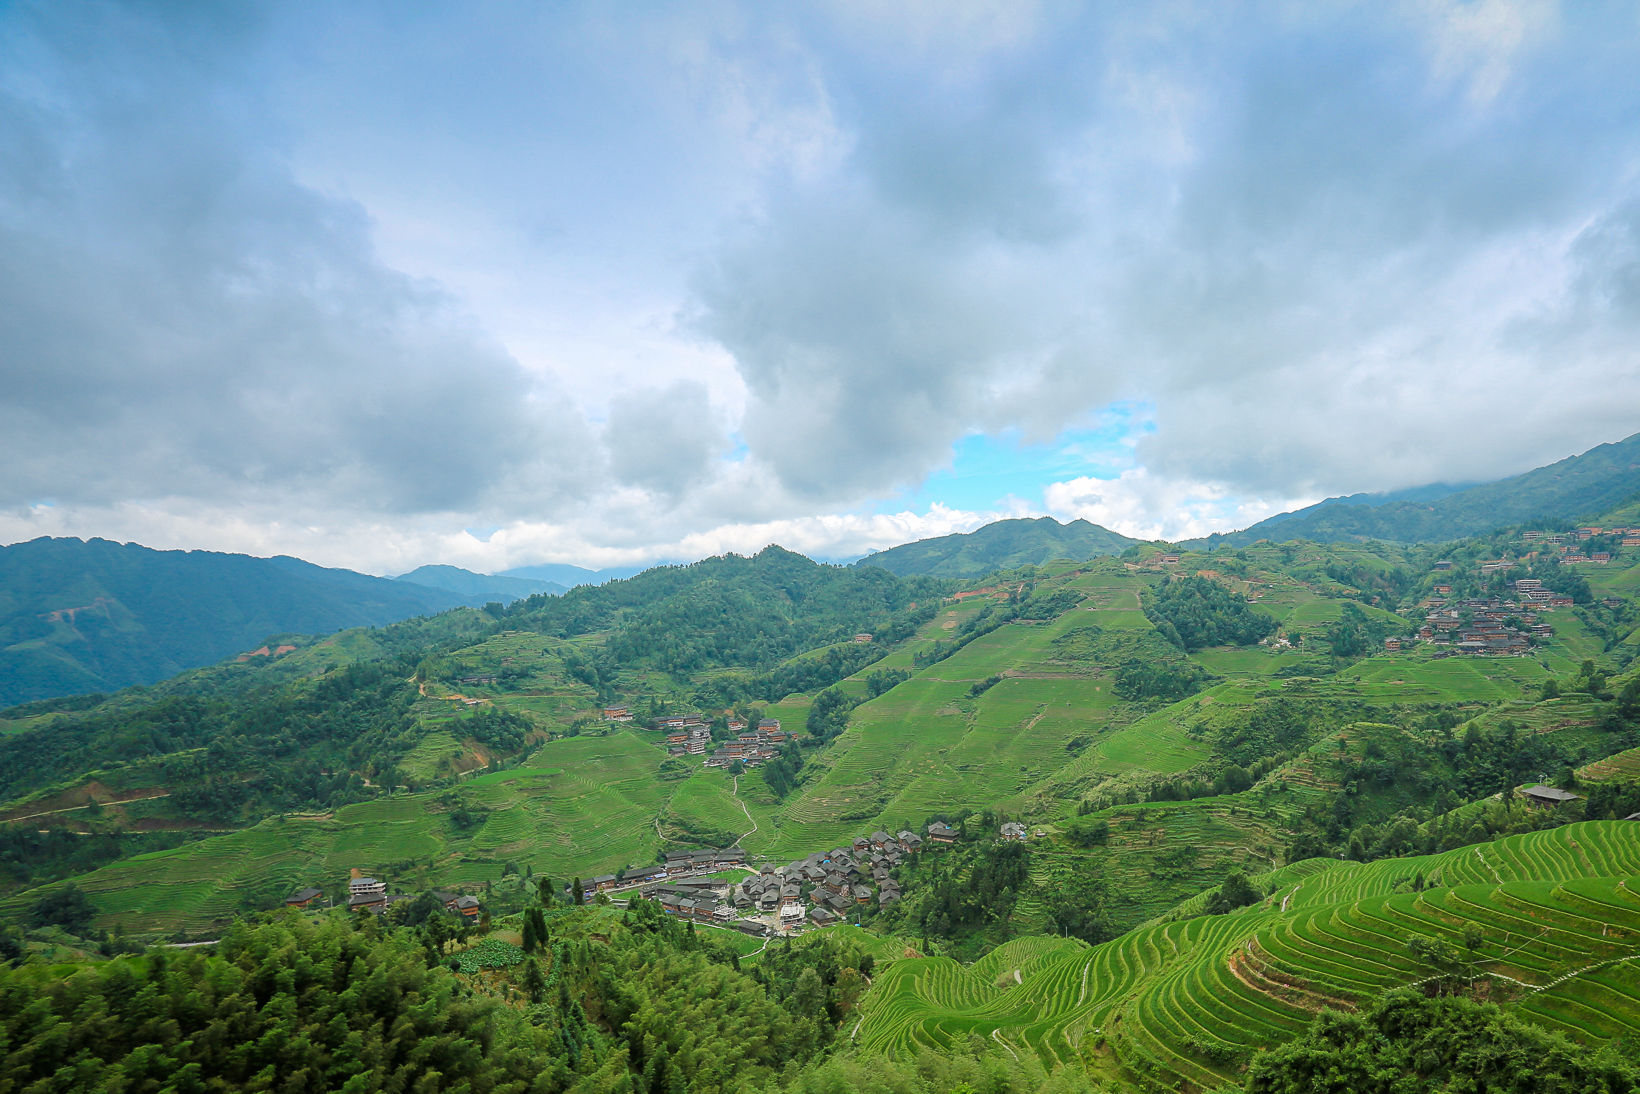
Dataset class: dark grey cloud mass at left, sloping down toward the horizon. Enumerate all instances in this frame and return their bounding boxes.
[0,8,603,513]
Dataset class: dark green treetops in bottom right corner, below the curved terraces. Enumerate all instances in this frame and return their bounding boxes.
[1246,991,1640,1094]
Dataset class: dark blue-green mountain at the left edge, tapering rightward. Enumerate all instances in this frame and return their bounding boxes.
[0,538,461,707]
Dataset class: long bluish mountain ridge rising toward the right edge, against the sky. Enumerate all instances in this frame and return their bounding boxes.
[1186,433,1640,548]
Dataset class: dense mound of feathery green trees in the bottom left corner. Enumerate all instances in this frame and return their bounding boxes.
[0,919,569,1094]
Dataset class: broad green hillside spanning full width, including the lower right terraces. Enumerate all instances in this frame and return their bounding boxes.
[0,521,1640,1091]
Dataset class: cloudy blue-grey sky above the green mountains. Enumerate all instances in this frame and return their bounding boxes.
[0,0,1640,574]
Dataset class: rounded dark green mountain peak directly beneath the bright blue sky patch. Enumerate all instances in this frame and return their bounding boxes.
[854,517,1140,577]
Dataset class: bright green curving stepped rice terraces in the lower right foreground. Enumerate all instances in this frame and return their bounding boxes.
[856,822,1640,1091]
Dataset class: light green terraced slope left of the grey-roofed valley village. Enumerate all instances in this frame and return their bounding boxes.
[0,730,771,933]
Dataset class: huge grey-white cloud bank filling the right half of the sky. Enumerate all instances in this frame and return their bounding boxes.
[695,2,1640,499]
